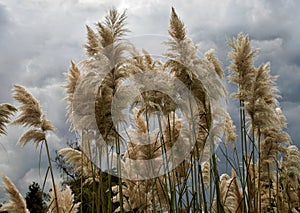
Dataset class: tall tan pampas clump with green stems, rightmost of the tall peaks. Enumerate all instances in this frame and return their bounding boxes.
[229,33,298,212]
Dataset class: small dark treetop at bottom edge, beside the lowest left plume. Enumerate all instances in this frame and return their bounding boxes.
[25,182,47,213]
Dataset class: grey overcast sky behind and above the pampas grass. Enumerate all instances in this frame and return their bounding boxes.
[0,0,300,199]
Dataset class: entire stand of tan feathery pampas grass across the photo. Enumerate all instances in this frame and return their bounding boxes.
[0,8,300,213]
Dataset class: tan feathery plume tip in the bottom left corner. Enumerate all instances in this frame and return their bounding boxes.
[0,176,29,213]
